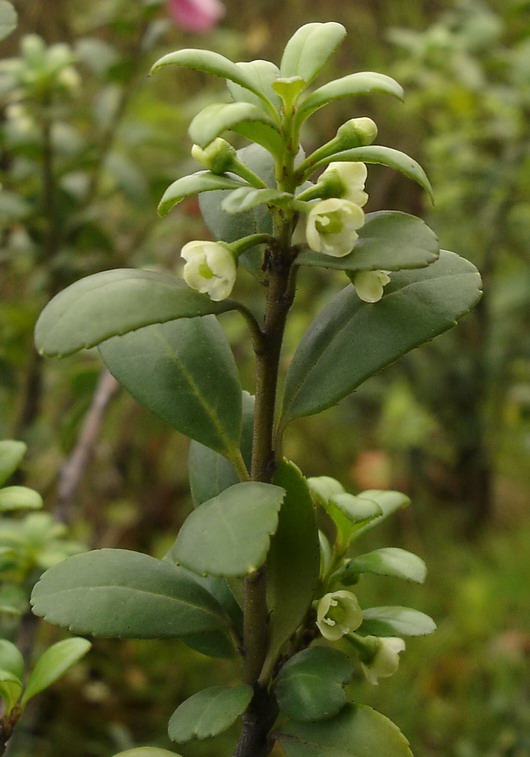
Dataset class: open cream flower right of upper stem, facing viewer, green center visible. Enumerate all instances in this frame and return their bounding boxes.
[306,197,364,258]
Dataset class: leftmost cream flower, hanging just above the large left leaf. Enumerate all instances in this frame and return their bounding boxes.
[180,241,237,302]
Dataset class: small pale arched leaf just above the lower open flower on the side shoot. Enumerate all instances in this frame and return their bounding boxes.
[342,547,427,584]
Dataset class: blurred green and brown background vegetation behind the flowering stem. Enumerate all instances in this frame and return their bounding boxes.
[0,0,530,757]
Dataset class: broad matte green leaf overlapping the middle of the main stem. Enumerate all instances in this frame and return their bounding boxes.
[172,481,285,576]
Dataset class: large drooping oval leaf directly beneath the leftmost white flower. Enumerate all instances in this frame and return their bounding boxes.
[35,268,235,357]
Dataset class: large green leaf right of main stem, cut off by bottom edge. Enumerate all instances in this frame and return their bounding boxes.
[277,704,413,757]
